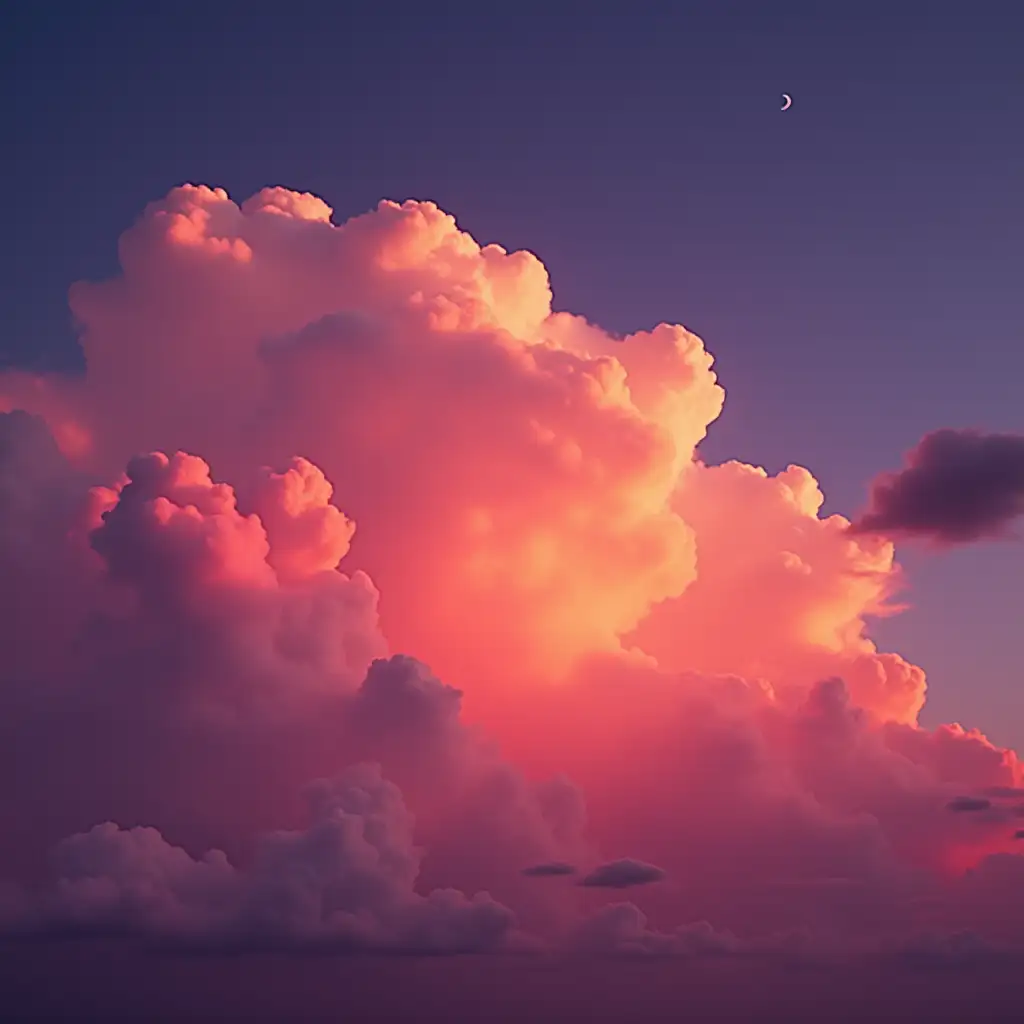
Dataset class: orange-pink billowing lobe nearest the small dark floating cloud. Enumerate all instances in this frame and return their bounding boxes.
[632,462,926,722]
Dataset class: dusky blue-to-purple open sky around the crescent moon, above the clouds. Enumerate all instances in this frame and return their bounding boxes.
[0,0,1024,743]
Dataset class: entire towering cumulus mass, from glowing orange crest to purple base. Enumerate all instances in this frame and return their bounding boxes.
[0,186,1024,955]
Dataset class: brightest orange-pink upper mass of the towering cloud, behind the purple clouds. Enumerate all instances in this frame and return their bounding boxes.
[0,185,925,729]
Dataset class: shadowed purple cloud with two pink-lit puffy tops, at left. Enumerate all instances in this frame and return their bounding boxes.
[0,440,581,888]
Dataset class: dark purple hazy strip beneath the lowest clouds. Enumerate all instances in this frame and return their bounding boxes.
[0,944,1020,1024]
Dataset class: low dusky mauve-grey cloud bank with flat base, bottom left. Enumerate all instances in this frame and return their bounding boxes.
[8,765,514,952]
